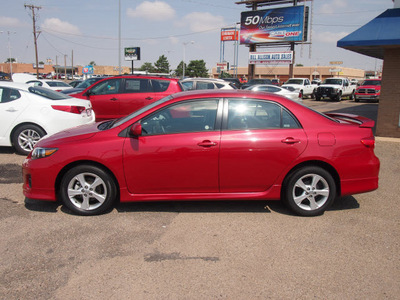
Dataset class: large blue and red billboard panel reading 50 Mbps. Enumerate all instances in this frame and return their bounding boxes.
[240,6,307,44]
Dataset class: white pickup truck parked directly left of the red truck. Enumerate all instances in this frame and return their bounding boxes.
[315,77,356,101]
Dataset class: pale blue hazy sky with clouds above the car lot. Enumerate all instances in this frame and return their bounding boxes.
[0,0,394,71]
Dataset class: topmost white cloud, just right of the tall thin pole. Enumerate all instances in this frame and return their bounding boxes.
[127,1,175,21]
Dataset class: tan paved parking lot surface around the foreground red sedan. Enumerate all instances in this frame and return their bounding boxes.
[0,100,400,299]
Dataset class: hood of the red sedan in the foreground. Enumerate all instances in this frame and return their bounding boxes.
[37,123,100,147]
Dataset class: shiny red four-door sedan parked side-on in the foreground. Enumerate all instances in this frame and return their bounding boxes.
[23,90,379,216]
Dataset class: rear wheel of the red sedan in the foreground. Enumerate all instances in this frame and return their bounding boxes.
[282,166,336,216]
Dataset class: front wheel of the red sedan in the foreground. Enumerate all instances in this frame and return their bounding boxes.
[60,165,117,216]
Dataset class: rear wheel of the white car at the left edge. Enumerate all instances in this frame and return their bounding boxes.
[11,124,46,155]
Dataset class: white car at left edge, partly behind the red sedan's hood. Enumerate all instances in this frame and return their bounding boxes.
[0,82,95,155]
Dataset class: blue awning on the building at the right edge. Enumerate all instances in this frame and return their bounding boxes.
[337,8,400,59]
